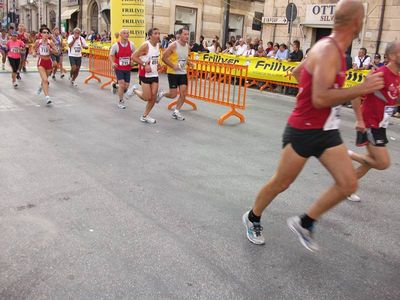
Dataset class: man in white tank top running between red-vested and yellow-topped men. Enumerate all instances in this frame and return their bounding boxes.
[128,28,161,124]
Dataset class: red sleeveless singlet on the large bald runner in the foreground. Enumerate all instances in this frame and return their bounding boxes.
[288,37,346,130]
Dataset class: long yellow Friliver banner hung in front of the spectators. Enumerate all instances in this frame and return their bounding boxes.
[194,53,369,87]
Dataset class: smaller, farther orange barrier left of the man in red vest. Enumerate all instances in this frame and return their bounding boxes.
[85,48,116,89]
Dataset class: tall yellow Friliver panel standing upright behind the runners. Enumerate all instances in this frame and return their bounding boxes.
[110,0,146,48]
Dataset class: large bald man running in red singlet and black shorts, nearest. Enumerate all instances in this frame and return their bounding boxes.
[243,0,383,251]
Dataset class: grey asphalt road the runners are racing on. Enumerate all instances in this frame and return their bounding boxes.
[0,73,400,300]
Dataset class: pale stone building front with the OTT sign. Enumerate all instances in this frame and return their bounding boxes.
[263,0,400,57]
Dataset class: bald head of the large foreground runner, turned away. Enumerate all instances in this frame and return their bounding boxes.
[333,0,365,39]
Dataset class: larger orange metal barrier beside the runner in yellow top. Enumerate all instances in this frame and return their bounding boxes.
[168,60,248,125]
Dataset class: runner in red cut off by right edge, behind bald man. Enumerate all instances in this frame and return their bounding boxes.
[347,42,400,201]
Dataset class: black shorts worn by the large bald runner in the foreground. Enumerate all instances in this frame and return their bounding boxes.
[283,125,343,158]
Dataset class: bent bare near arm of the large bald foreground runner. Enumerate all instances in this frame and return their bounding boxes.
[307,44,384,108]
